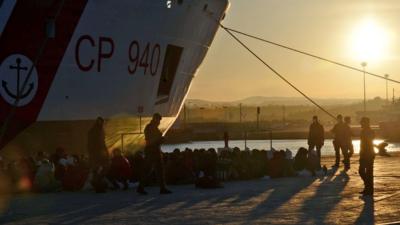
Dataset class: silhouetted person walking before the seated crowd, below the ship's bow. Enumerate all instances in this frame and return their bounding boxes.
[136,113,172,195]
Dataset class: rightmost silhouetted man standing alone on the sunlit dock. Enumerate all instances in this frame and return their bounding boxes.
[358,117,375,196]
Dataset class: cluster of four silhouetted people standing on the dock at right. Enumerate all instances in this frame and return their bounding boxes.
[308,115,375,196]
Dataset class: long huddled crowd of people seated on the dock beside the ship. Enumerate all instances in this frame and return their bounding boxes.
[0,148,321,192]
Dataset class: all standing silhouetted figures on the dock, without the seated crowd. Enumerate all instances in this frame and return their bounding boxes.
[88,113,375,195]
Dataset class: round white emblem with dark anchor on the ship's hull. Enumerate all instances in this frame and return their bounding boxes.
[0,54,38,107]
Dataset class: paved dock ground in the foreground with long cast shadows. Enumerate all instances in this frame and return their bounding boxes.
[0,156,400,224]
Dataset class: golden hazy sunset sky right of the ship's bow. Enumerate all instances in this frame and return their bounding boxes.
[189,0,400,101]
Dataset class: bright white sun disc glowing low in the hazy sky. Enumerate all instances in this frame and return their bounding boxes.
[351,19,390,62]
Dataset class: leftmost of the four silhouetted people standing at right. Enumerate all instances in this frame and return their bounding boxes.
[308,116,325,167]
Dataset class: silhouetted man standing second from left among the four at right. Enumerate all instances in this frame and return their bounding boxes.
[332,114,348,167]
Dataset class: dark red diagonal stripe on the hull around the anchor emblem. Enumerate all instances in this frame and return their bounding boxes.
[0,0,87,149]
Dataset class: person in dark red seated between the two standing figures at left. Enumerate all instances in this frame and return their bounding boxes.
[108,148,132,190]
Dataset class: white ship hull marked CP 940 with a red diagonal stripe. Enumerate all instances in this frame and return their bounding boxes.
[0,0,228,156]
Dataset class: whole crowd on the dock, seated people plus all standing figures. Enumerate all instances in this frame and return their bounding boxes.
[0,114,388,194]
